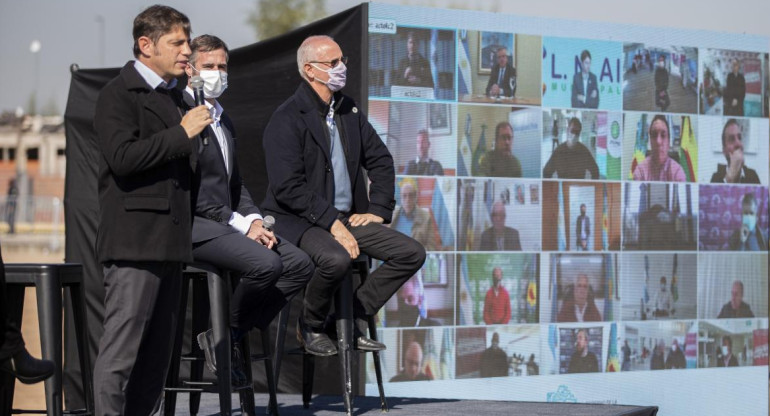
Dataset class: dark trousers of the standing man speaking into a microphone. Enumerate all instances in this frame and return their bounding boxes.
[94,261,182,416]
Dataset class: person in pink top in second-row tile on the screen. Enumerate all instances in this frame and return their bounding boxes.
[634,114,686,182]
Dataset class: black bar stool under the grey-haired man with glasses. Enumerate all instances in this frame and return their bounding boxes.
[274,254,388,416]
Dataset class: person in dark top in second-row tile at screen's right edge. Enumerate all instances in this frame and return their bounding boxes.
[711,118,759,184]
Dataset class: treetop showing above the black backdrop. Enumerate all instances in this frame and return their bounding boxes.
[246,0,326,40]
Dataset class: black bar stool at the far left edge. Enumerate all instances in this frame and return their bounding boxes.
[0,263,94,416]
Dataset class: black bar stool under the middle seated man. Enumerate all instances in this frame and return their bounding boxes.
[164,263,278,416]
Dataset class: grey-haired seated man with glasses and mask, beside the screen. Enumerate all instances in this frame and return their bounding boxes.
[262,36,425,356]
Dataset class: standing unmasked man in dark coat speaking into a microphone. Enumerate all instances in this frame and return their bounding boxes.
[92,5,212,416]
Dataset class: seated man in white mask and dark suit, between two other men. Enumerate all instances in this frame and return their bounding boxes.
[184,35,314,376]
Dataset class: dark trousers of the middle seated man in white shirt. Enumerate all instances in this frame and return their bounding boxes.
[193,233,314,331]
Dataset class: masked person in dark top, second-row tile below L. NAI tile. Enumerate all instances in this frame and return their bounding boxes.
[543,117,599,179]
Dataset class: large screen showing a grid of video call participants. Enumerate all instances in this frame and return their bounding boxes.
[367,4,770,409]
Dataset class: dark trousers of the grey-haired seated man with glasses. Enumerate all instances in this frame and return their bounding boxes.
[299,221,425,328]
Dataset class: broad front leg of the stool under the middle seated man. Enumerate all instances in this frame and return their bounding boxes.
[207,272,232,416]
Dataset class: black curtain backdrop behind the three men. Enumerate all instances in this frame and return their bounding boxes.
[64,3,368,409]
